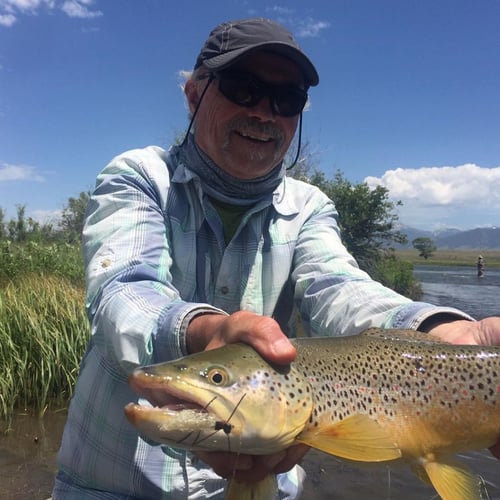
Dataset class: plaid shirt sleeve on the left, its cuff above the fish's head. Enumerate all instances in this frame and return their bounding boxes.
[83,147,224,371]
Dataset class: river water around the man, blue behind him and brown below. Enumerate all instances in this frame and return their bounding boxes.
[0,265,500,500]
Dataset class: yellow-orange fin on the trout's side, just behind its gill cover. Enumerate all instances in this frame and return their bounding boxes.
[297,415,401,462]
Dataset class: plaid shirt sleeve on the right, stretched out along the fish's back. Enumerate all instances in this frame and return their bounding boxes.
[292,187,472,336]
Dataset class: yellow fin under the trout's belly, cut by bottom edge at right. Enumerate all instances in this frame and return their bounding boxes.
[423,458,483,500]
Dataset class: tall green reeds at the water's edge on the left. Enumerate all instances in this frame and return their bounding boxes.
[0,273,89,420]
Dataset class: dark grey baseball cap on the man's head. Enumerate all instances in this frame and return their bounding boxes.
[194,18,319,86]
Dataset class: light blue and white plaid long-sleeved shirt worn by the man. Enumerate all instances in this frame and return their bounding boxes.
[54,147,465,499]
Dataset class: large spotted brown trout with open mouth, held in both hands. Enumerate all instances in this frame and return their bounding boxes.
[125,328,500,500]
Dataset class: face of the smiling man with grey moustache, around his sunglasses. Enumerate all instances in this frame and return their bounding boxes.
[186,52,303,179]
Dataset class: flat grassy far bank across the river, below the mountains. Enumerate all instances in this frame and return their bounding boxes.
[396,248,500,269]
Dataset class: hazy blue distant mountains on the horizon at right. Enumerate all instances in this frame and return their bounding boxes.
[399,226,500,250]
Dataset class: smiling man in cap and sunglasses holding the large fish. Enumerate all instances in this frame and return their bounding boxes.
[53,19,500,499]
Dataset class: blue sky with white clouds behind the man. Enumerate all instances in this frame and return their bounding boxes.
[0,0,500,229]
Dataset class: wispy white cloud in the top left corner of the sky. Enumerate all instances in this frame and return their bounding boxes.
[0,0,103,27]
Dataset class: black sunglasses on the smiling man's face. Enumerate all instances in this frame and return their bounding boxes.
[201,70,307,117]
